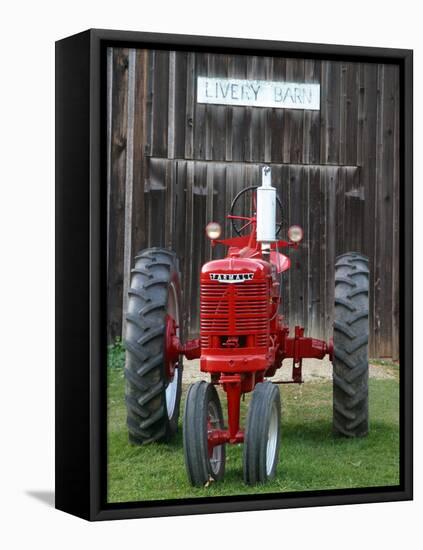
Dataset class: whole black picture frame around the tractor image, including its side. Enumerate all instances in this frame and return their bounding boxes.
[56,29,413,520]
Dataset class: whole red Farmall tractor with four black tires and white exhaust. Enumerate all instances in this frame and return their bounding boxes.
[125,167,369,486]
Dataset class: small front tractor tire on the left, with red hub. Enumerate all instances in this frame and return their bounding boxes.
[183,381,226,487]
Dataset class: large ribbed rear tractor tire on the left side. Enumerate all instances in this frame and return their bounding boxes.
[124,248,182,444]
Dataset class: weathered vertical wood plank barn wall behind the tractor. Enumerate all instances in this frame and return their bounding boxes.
[107,48,400,359]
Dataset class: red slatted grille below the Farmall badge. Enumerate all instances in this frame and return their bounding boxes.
[200,281,269,348]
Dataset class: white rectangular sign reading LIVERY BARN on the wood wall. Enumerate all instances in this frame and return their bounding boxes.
[197,76,320,111]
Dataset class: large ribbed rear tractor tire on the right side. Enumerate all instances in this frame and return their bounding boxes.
[332,252,369,437]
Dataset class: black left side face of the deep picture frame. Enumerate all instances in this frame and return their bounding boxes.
[55,32,92,519]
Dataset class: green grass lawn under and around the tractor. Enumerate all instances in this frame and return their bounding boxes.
[108,349,399,502]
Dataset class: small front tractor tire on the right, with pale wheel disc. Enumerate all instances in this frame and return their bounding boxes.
[244,382,281,485]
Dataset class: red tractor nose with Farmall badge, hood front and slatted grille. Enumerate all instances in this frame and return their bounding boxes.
[200,257,277,378]
